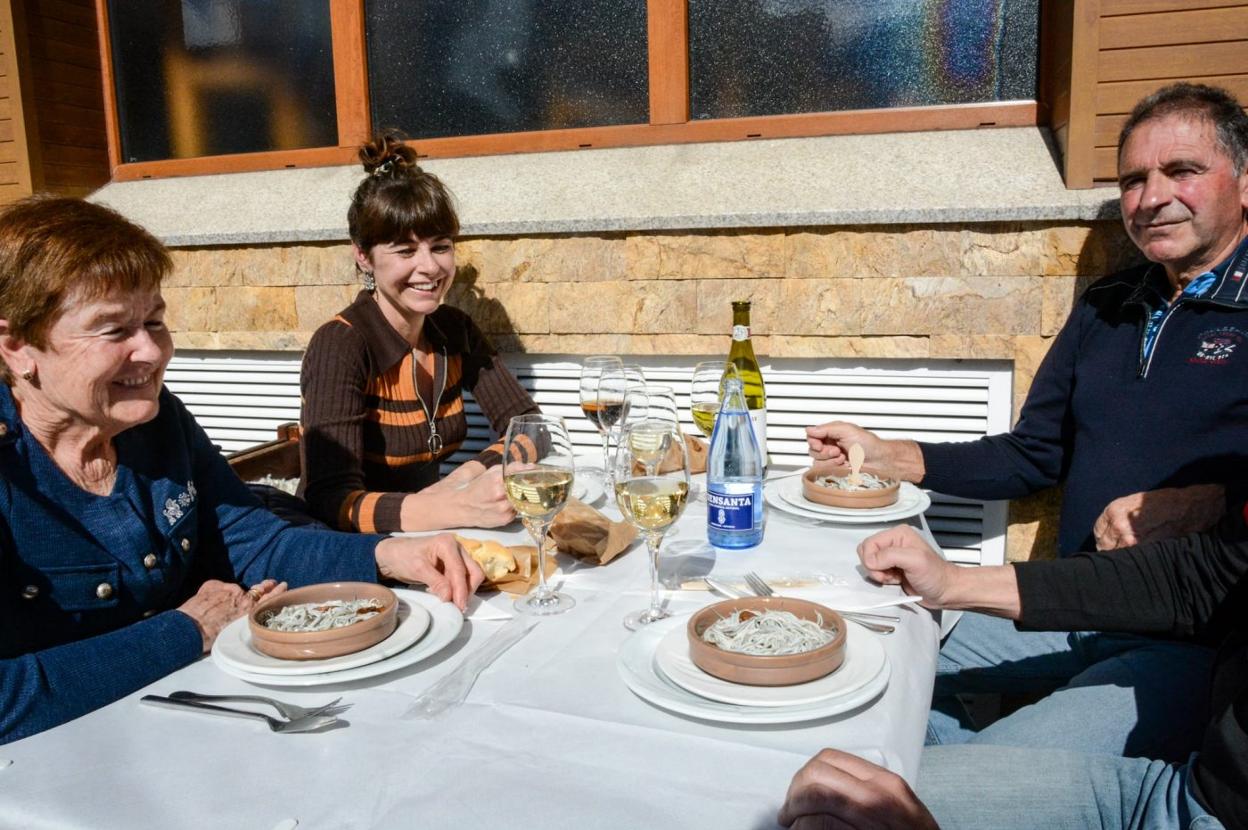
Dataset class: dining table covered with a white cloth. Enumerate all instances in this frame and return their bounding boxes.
[0,471,941,830]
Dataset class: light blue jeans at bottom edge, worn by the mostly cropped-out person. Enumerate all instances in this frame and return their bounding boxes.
[915,746,1223,830]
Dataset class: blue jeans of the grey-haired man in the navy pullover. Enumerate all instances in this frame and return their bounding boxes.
[927,614,1213,761]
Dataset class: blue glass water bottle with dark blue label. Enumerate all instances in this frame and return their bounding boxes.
[706,378,763,548]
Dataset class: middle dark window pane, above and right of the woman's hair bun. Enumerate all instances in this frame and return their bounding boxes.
[364,0,649,137]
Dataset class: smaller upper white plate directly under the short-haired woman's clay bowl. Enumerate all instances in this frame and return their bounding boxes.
[212,592,429,675]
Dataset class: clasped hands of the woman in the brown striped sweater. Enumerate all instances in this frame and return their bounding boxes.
[399,461,515,530]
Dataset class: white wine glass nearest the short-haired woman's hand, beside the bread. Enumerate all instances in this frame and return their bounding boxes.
[503,414,577,615]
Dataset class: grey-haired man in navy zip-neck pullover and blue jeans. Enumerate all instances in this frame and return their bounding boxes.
[809,84,1248,759]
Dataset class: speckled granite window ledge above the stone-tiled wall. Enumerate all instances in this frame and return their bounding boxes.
[92,127,1118,247]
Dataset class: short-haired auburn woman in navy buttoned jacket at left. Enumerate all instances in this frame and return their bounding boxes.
[0,197,482,743]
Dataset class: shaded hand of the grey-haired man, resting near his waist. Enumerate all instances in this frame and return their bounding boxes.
[1092,484,1227,550]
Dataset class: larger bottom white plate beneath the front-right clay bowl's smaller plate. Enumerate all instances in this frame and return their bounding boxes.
[615,617,889,724]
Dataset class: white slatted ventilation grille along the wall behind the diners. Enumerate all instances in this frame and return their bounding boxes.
[166,352,1012,564]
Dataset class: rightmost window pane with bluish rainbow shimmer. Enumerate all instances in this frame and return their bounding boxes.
[689,0,1040,119]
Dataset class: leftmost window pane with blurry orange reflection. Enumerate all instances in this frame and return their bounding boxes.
[109,0,338,161]
